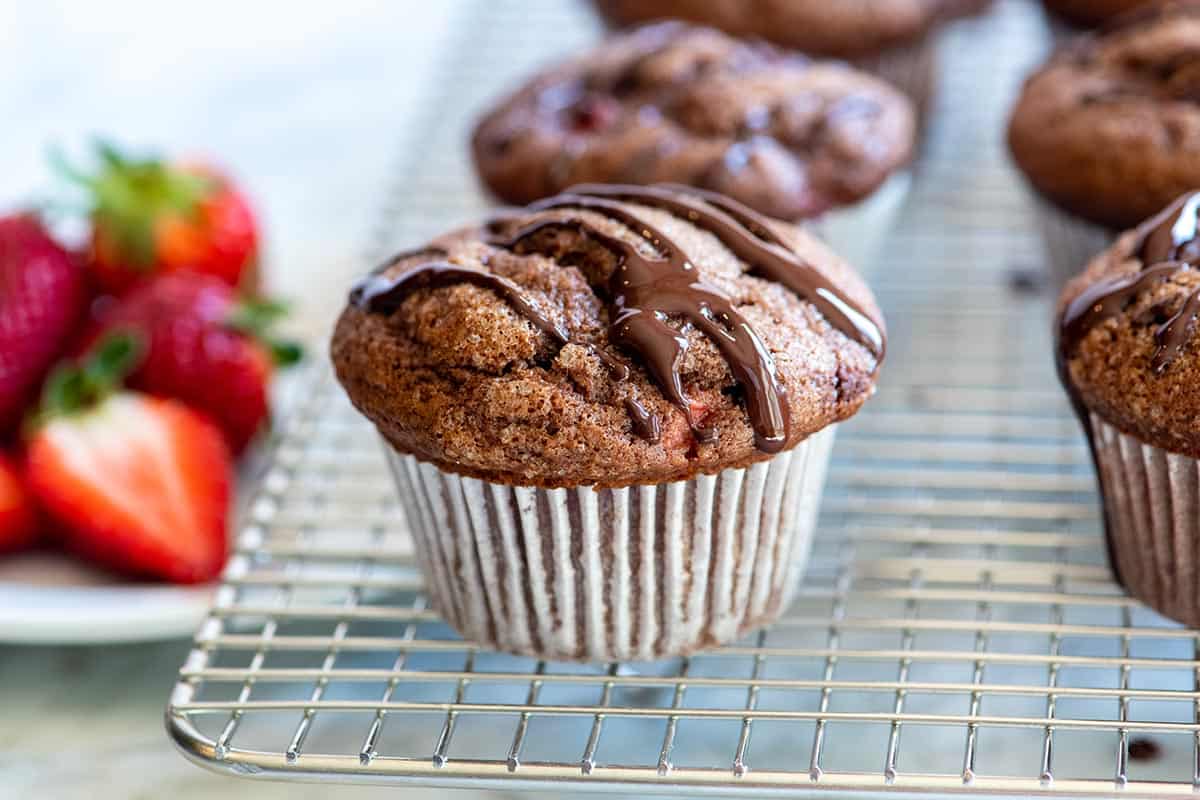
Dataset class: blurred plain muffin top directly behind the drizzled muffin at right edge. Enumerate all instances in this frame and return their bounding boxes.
[1008,0,1200,228]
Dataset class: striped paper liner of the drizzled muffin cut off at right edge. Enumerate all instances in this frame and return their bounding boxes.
[1091,414,1200,627]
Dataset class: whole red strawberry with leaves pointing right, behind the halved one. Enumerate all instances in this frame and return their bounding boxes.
[85,272,300,455]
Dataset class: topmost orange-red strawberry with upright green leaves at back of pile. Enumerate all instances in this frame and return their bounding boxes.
[60,144,258,294]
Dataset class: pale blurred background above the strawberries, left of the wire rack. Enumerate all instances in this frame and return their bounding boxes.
[0,0,461,333]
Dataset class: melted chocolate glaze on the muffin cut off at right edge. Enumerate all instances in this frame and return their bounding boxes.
[1056,192,1200,582]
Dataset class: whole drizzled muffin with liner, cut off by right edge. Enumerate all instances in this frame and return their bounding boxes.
[1057,193,1200,627]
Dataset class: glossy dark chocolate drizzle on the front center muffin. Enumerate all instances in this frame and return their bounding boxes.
[350,186,886,453]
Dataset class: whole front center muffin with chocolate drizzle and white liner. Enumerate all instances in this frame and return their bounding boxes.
[332,185,884,660]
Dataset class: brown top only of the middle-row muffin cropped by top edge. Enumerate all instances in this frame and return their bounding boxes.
[595,0,990,58]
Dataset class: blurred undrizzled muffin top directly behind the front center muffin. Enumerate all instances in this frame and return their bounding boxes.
[473,23,914,219]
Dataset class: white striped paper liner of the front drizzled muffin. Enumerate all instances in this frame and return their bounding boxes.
[385,427,834,661]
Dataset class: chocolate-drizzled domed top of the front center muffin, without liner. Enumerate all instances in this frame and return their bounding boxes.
[332,186,884,487]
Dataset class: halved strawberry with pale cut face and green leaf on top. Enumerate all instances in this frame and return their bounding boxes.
[25,337,232,583]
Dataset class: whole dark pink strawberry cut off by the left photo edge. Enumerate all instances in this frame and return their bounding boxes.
[0,215,86,437]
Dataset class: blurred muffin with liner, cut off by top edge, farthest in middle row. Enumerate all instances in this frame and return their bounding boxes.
[595,0,990,109]
